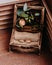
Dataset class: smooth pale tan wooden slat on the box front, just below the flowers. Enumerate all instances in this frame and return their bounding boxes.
[14,31,40,40]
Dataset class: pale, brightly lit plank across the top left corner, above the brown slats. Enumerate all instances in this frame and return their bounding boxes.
[0,0,39,6]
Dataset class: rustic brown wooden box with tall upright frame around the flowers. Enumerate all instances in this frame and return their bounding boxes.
[9,4,45,52]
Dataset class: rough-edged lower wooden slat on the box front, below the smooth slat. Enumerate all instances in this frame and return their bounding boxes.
[10,39,39,47]
